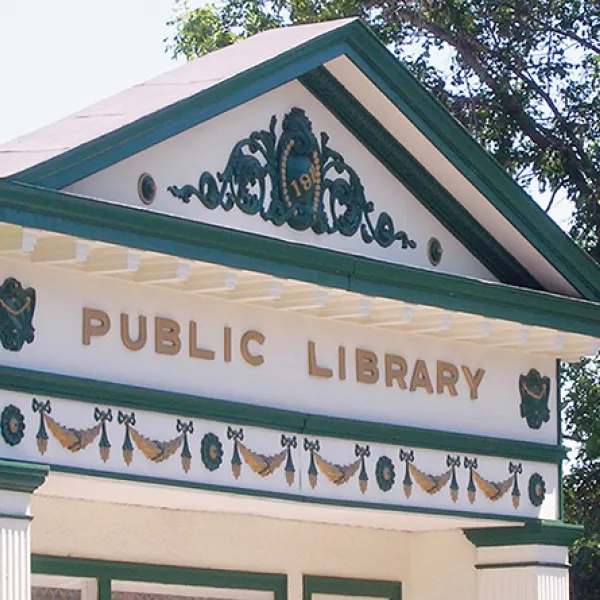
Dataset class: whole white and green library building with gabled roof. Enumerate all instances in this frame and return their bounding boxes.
[0,20,600,600]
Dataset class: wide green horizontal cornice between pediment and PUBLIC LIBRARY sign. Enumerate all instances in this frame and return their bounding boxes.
[0,181,600,337]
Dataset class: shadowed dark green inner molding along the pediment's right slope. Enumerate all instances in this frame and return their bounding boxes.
[299,67,543,290]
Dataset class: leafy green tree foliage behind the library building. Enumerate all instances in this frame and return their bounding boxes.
[167,0,600,600]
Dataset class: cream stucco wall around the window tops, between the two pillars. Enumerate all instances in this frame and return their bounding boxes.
[32,496,477,600]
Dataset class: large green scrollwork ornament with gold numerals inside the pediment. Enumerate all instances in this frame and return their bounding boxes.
[167,108,417,249]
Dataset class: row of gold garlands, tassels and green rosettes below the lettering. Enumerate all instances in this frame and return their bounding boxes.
[0,398,546,510]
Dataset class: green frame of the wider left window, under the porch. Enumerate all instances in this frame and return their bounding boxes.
[31,554,287,600]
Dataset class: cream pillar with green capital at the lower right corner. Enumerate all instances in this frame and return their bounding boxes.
[465,521,580,600]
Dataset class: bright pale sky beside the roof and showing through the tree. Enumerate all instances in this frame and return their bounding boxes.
[0,0,570,227]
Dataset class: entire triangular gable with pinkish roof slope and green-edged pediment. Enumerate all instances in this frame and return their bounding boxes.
[0,20,600,299]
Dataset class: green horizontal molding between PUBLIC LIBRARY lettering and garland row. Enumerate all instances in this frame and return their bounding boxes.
[0,366,565,463]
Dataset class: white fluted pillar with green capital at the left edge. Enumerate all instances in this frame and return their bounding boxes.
[0,460,48,600]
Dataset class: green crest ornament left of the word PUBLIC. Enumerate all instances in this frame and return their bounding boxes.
[0,277,35,352]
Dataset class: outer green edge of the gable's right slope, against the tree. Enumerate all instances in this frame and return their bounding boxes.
[340,22,600,300]
